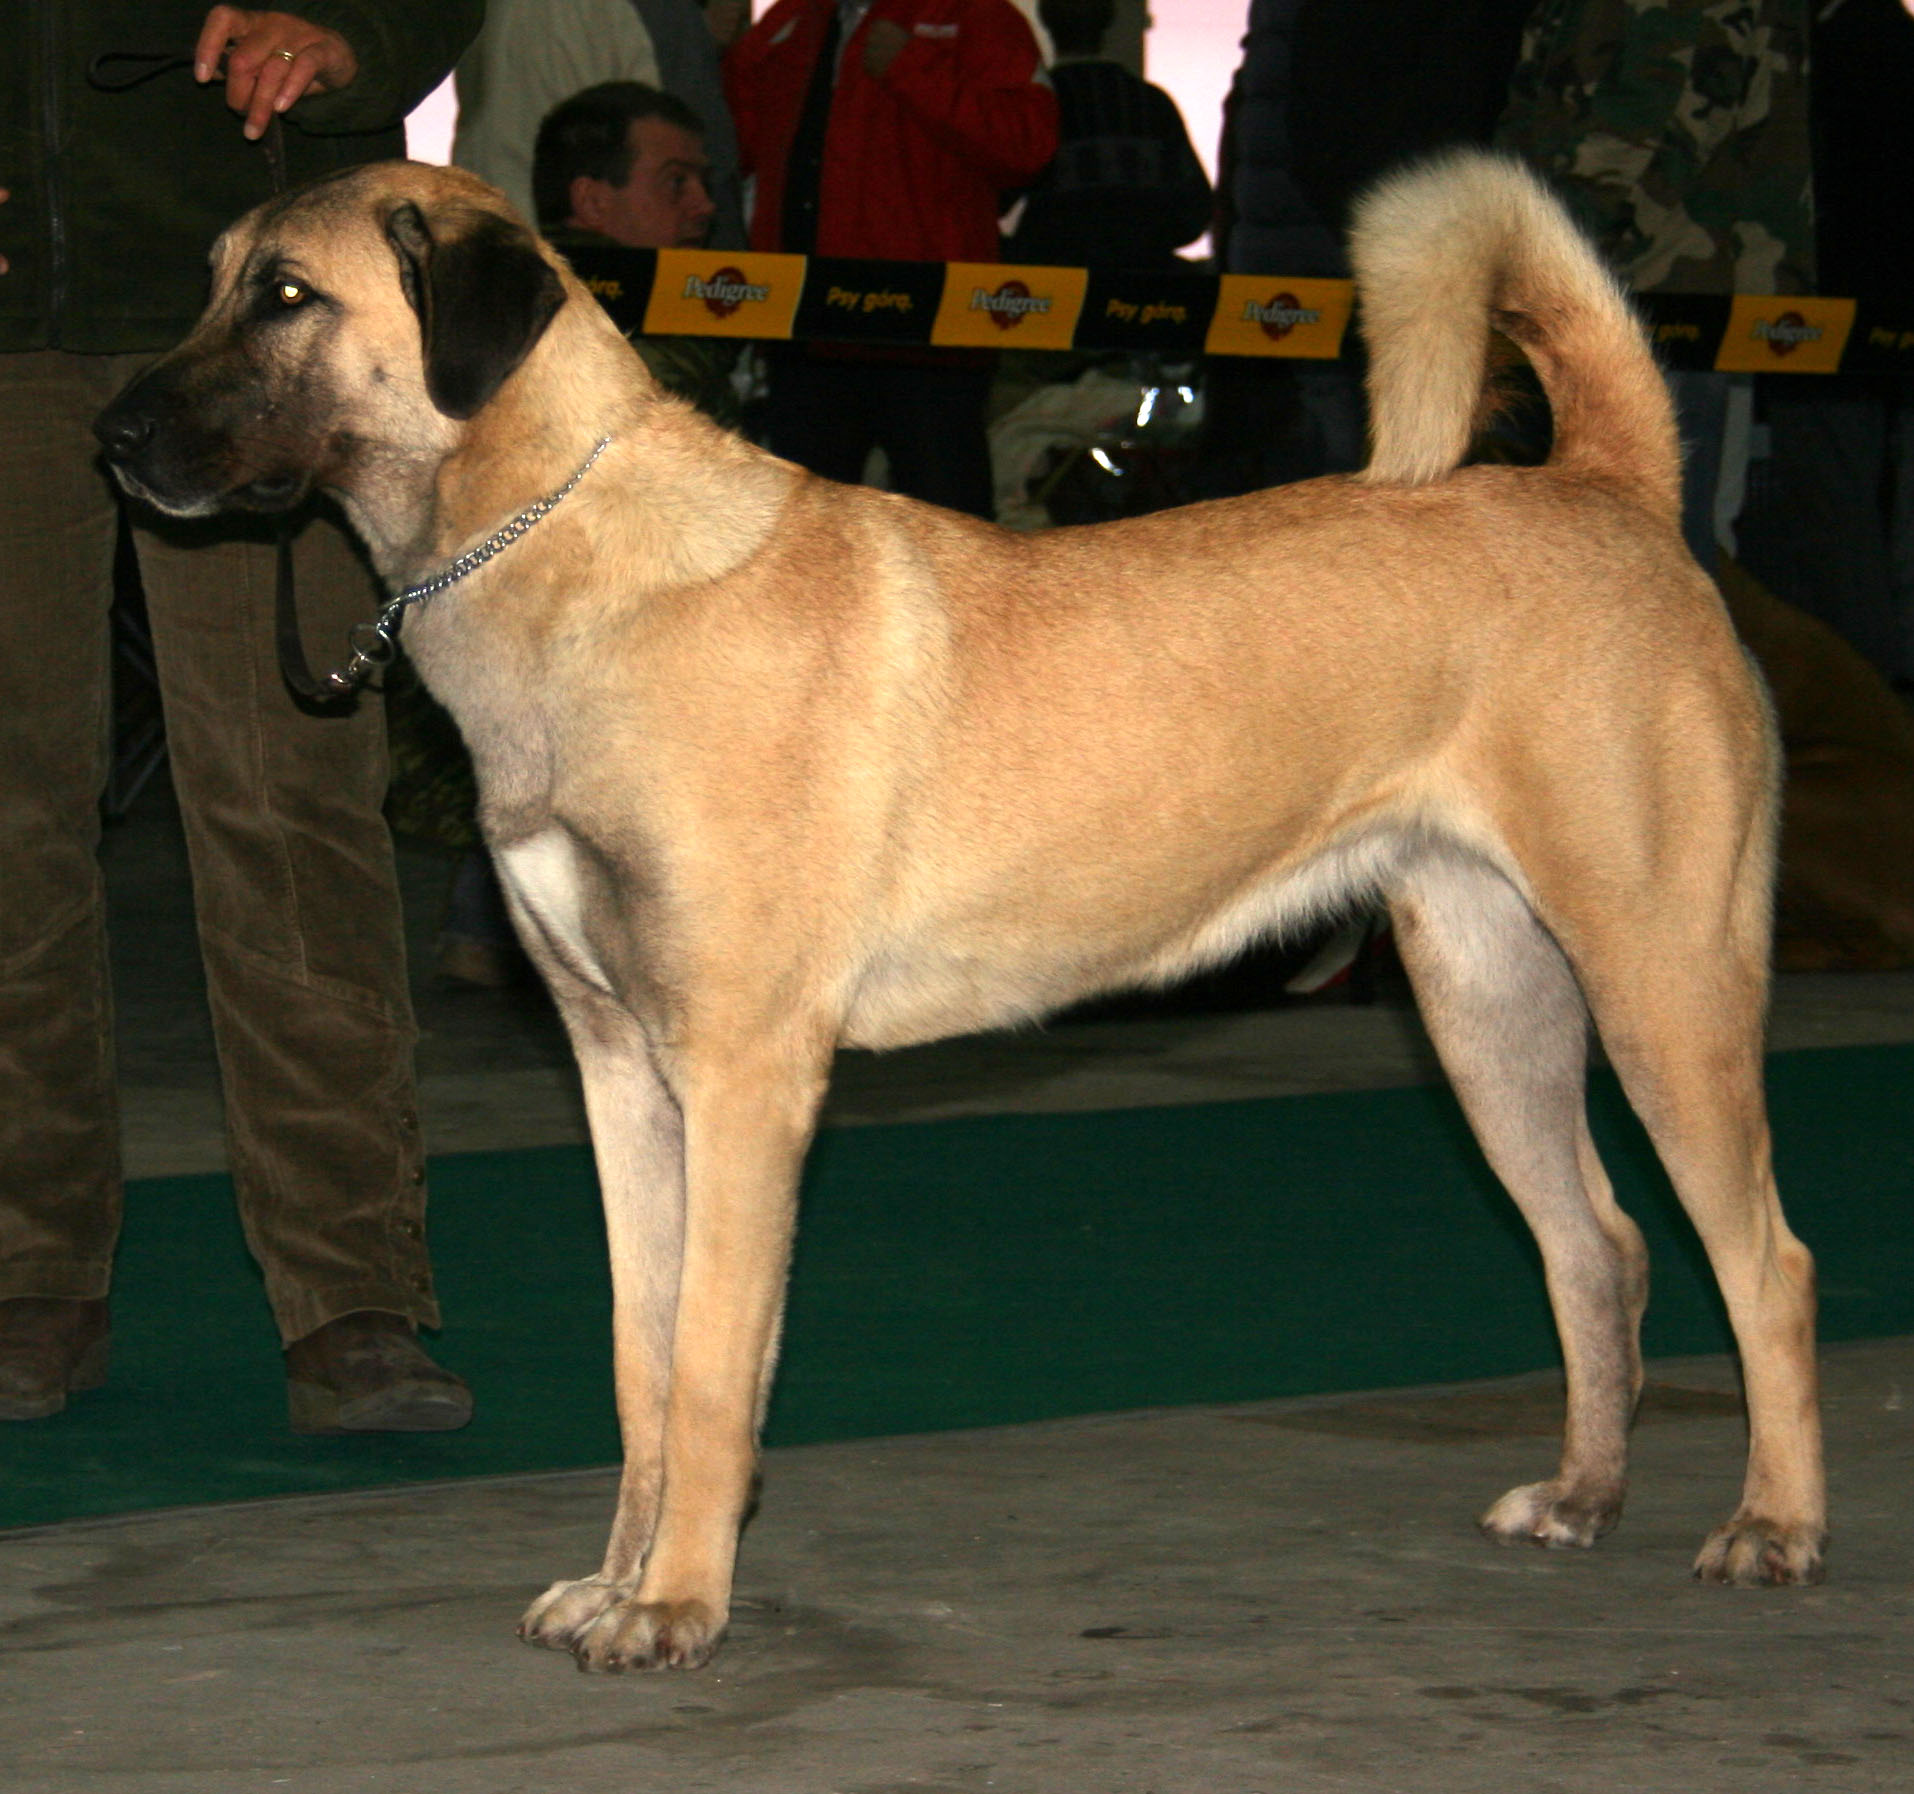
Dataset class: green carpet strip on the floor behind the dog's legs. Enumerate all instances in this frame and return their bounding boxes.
[0,1045,1914,1526]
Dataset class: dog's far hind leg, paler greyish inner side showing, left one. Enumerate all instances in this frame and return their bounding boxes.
[1390,848,1648,1545]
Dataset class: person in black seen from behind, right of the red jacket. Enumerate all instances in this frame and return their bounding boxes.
[1005,0,1210,268]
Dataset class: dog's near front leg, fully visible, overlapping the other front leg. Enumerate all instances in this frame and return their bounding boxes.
[558,1030,829,1670]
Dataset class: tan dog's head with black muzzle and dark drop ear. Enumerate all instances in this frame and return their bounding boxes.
[94,163,565,517]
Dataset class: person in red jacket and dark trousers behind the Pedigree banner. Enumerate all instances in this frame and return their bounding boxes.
[725,0,1057,517]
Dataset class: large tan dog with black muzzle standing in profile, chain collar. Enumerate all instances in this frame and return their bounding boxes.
[100,157,1824,1668]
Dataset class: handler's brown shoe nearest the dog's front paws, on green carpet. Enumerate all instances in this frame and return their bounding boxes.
[285,1312,473,1432]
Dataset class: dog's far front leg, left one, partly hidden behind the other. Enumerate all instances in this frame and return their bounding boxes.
[519,1018,685,1650]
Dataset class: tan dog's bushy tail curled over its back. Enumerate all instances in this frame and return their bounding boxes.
[1349,149,1680,519]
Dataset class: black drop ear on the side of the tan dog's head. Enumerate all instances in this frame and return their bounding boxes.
[385,201,565,417]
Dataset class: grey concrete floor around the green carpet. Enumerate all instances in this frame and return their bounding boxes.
[0,777,1914,1794]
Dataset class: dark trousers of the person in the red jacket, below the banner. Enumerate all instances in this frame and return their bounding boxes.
[766,348,995,517]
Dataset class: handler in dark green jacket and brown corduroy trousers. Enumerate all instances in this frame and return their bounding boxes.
[0,0,482,1432]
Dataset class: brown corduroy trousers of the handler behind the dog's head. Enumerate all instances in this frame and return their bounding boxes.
[0,350,438,1340]
